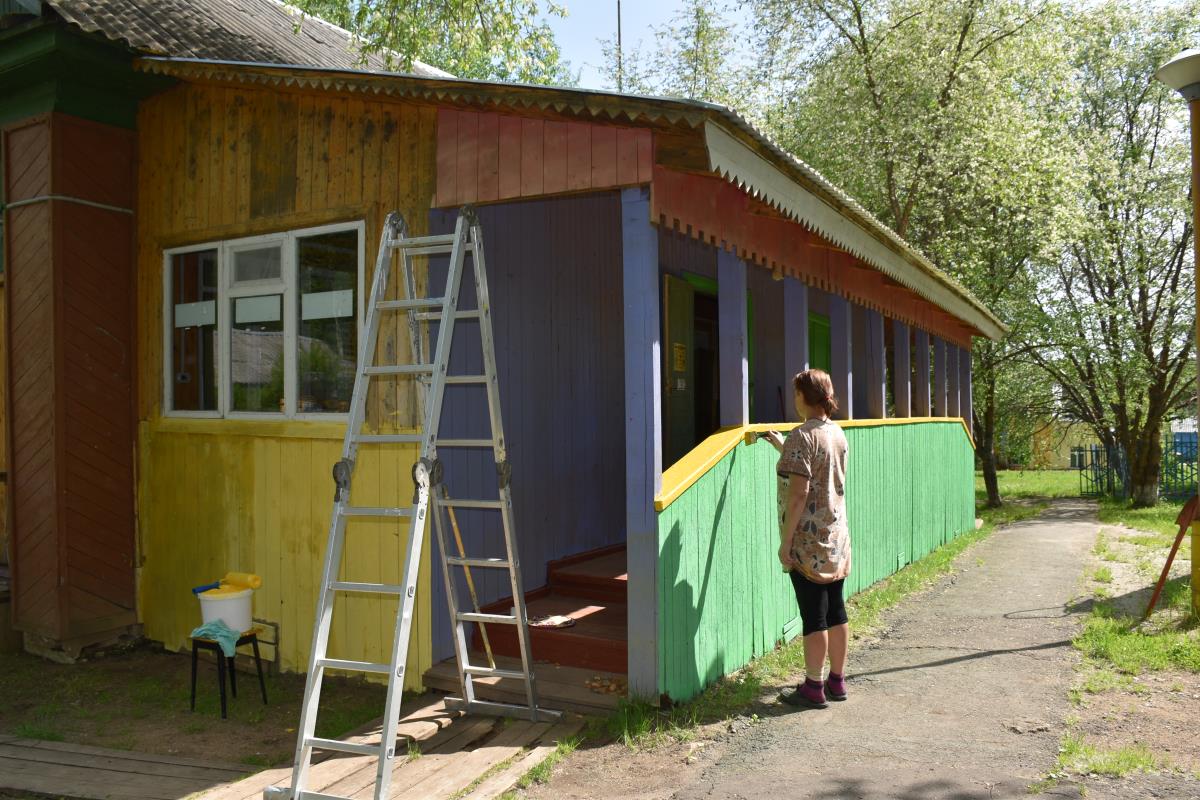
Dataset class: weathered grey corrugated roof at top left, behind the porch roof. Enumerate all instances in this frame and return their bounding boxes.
[46,0,450,78]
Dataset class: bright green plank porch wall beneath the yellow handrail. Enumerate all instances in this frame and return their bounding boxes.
[658,422,974,700]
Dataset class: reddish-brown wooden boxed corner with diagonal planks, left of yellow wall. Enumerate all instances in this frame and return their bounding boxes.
[4,114,137,652]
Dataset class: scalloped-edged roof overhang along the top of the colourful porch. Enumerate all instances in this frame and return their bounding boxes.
[133,59,1008,338]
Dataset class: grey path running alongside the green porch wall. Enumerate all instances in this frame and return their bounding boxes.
[530,500,1196,800]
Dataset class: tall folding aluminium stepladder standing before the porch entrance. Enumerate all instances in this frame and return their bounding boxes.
[263,206,559,800]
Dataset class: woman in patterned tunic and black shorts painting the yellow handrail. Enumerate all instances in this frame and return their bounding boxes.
[761,369,850,709]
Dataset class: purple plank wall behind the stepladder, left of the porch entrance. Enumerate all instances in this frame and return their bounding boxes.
[430,192,625,658]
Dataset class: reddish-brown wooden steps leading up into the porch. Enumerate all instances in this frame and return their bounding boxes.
[472,545,629,674]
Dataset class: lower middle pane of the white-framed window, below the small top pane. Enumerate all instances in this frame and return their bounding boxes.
[229,294,283,413]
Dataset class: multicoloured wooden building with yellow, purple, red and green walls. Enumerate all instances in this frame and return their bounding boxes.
[0,0,1002,698]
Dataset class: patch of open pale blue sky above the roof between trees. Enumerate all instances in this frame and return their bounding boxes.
[548,0,683,89]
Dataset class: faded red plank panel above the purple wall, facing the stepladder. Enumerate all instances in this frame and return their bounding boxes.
[434,108,654,206]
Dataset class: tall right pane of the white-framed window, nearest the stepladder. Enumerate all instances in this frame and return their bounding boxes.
[296,230,359,414]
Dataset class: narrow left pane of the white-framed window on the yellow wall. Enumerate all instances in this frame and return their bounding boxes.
[168,249,217,411]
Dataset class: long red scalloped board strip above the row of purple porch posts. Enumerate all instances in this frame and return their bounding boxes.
[650,166,972,349]
